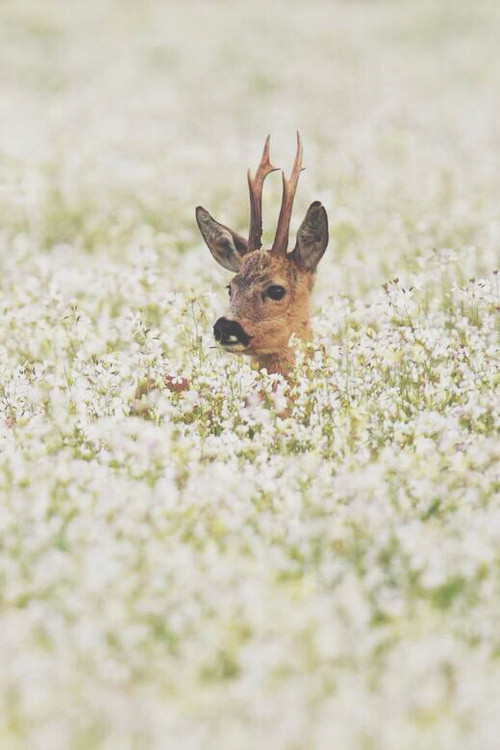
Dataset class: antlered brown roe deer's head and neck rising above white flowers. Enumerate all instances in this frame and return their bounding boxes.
[196,133,328,373]
